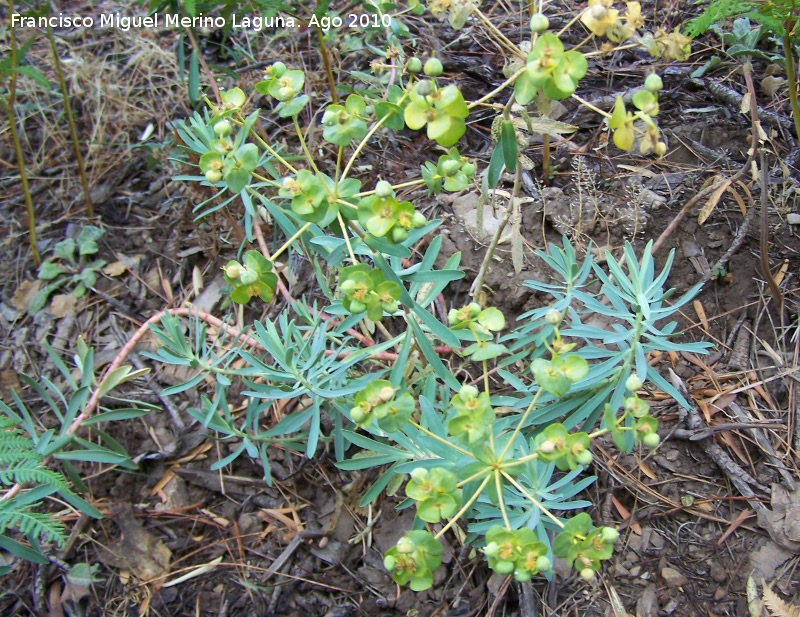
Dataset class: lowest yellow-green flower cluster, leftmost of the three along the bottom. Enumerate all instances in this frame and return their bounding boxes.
[383,529,442,591]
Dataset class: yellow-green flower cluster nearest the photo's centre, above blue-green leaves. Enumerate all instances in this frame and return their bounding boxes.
[339,264,401,321]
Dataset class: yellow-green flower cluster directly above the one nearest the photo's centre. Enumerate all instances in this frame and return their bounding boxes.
[358,180,428,243]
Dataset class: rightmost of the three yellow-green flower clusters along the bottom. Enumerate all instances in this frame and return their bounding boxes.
[553,512,619,581]
